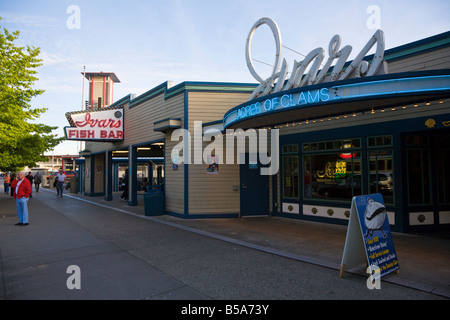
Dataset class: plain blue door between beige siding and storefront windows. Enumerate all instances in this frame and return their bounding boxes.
[240,154,269,216]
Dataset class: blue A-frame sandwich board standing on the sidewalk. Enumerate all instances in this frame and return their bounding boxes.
[339,193,399,278]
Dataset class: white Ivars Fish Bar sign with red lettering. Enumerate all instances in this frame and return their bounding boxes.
[64,107,124,142]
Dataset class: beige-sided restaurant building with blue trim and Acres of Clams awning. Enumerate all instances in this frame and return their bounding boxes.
[66,20,450,232]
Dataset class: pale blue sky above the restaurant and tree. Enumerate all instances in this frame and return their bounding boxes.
[0,0,450,155]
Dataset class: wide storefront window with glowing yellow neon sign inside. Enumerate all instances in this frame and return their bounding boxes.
[303,139,361,201]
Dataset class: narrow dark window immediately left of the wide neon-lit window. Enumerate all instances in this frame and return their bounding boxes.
[282,144,299,198]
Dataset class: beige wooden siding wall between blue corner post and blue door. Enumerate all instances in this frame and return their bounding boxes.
[186,92,249,214]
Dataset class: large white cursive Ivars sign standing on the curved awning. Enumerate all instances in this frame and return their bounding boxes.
[245,18,384,100]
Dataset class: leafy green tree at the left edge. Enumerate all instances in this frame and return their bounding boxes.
[0,17,64,171]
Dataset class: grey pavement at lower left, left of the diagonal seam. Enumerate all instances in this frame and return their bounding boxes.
[0,190,209,300]
